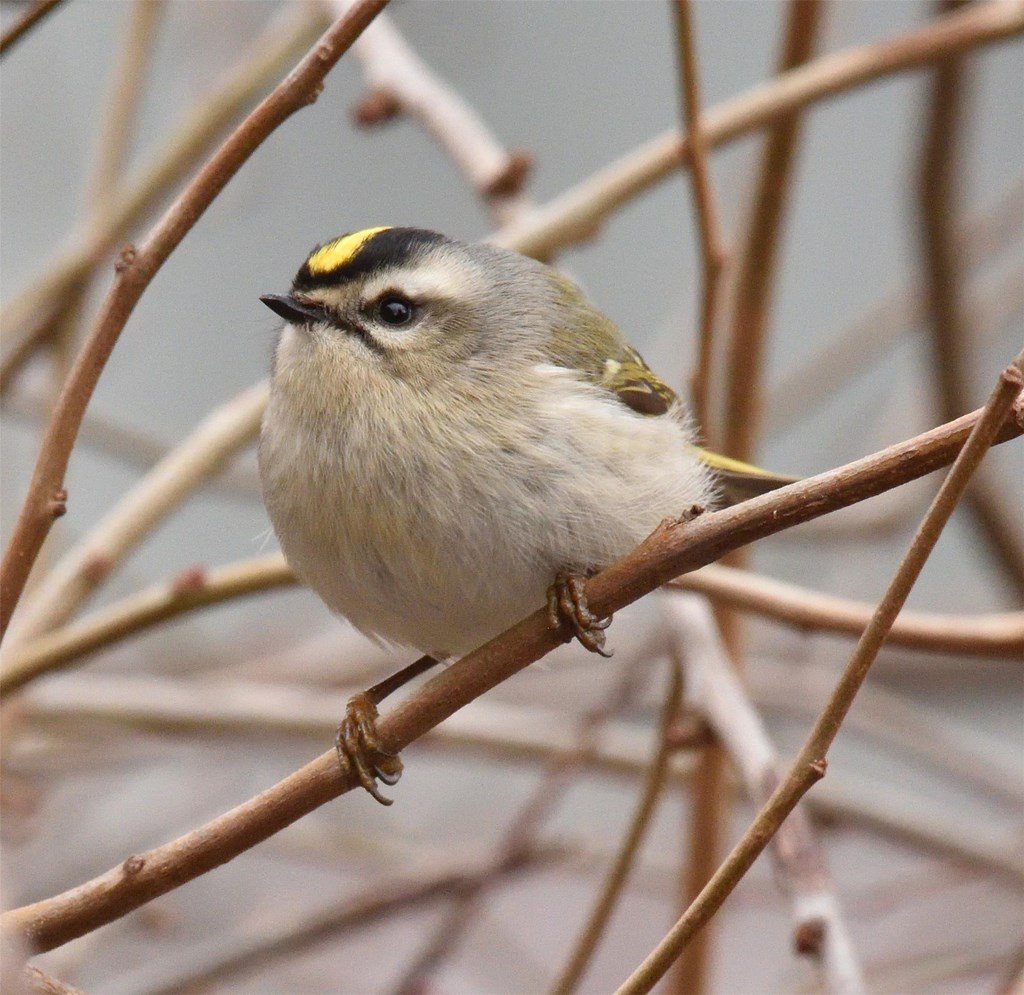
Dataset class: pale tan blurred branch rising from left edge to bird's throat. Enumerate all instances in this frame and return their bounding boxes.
[0,383,267,652]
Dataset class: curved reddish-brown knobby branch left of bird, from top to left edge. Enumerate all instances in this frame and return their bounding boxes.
[0,0,387,635]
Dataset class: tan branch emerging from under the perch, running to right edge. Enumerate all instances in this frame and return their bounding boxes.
[671,564,1024,659]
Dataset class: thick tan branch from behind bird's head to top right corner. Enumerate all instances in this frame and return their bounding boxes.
[492,0,1024,259]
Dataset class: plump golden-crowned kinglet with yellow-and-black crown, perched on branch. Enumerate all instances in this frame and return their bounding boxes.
[259,227,784,801]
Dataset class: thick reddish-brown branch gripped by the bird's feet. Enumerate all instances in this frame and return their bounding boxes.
[0,387,1021,950]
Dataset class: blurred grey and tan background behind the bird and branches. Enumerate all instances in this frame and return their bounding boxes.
[0,0,1024,993]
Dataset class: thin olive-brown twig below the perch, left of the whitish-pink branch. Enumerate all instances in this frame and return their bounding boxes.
[551,662,683,995]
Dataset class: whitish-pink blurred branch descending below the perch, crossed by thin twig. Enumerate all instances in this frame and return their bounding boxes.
[663,595,866,995]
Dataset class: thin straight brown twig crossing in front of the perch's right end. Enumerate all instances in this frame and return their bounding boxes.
[618,353,1024,995]
